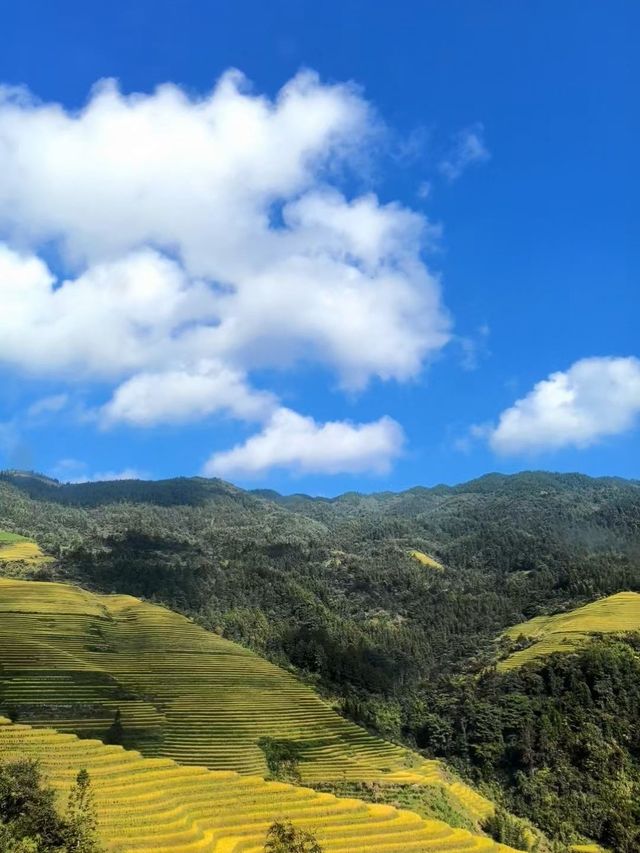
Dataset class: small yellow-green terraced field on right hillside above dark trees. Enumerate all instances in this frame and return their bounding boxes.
[498,592,640,670]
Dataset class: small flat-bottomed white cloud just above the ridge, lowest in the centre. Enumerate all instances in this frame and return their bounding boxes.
[205,408,404,477]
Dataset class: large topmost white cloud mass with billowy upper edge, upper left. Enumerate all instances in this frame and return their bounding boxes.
[0,72,373,268]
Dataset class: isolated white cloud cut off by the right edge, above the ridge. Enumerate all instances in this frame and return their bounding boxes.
[488,357,640,454]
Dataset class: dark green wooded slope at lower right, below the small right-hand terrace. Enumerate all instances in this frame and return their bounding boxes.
[421,634,640,853]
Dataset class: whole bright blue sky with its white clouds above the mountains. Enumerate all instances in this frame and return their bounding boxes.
[0,0,640,494]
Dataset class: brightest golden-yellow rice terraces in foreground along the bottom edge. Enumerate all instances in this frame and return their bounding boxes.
[0,718,512,853]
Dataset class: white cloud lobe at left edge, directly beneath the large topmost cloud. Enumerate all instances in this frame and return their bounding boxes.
[0,244,214,379]
